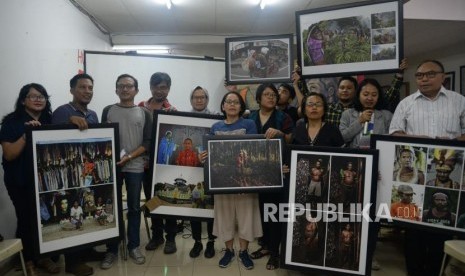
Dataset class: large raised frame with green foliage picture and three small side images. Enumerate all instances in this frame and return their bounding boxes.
[296,0,403,77]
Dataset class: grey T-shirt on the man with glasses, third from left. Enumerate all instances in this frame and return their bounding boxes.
[102,104,152,173]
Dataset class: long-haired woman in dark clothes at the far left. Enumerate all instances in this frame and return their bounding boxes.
[0,83,59,276]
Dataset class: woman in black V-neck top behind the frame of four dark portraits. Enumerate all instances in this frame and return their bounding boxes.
[292,92,344,147]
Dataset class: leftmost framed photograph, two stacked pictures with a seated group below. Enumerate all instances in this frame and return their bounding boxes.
[27,124,124,254]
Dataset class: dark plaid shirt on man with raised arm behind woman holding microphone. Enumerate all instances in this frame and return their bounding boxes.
[325,73,403,126]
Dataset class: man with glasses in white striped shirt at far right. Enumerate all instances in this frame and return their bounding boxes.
[389,60,465,275]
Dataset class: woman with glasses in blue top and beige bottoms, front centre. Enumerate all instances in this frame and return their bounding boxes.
[199,92,262,269]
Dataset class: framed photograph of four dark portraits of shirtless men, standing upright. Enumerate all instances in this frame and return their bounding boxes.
[282,146,378,275]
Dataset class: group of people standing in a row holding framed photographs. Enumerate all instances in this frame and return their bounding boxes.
[0,57,465,275]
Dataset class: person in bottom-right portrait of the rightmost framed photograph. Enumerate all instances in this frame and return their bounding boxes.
[422,191,456,226]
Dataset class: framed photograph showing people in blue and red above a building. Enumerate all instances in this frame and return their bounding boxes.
[150,111,222,218]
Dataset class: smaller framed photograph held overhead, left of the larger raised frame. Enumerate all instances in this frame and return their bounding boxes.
[225,34,293,84]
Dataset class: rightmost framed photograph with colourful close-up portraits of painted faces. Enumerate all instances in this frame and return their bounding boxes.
[372,135,465,232]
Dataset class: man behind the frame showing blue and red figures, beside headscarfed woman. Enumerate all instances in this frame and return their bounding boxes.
[139,72,177,254]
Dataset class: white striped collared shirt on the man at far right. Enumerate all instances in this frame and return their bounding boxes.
[389,87,465,138]
